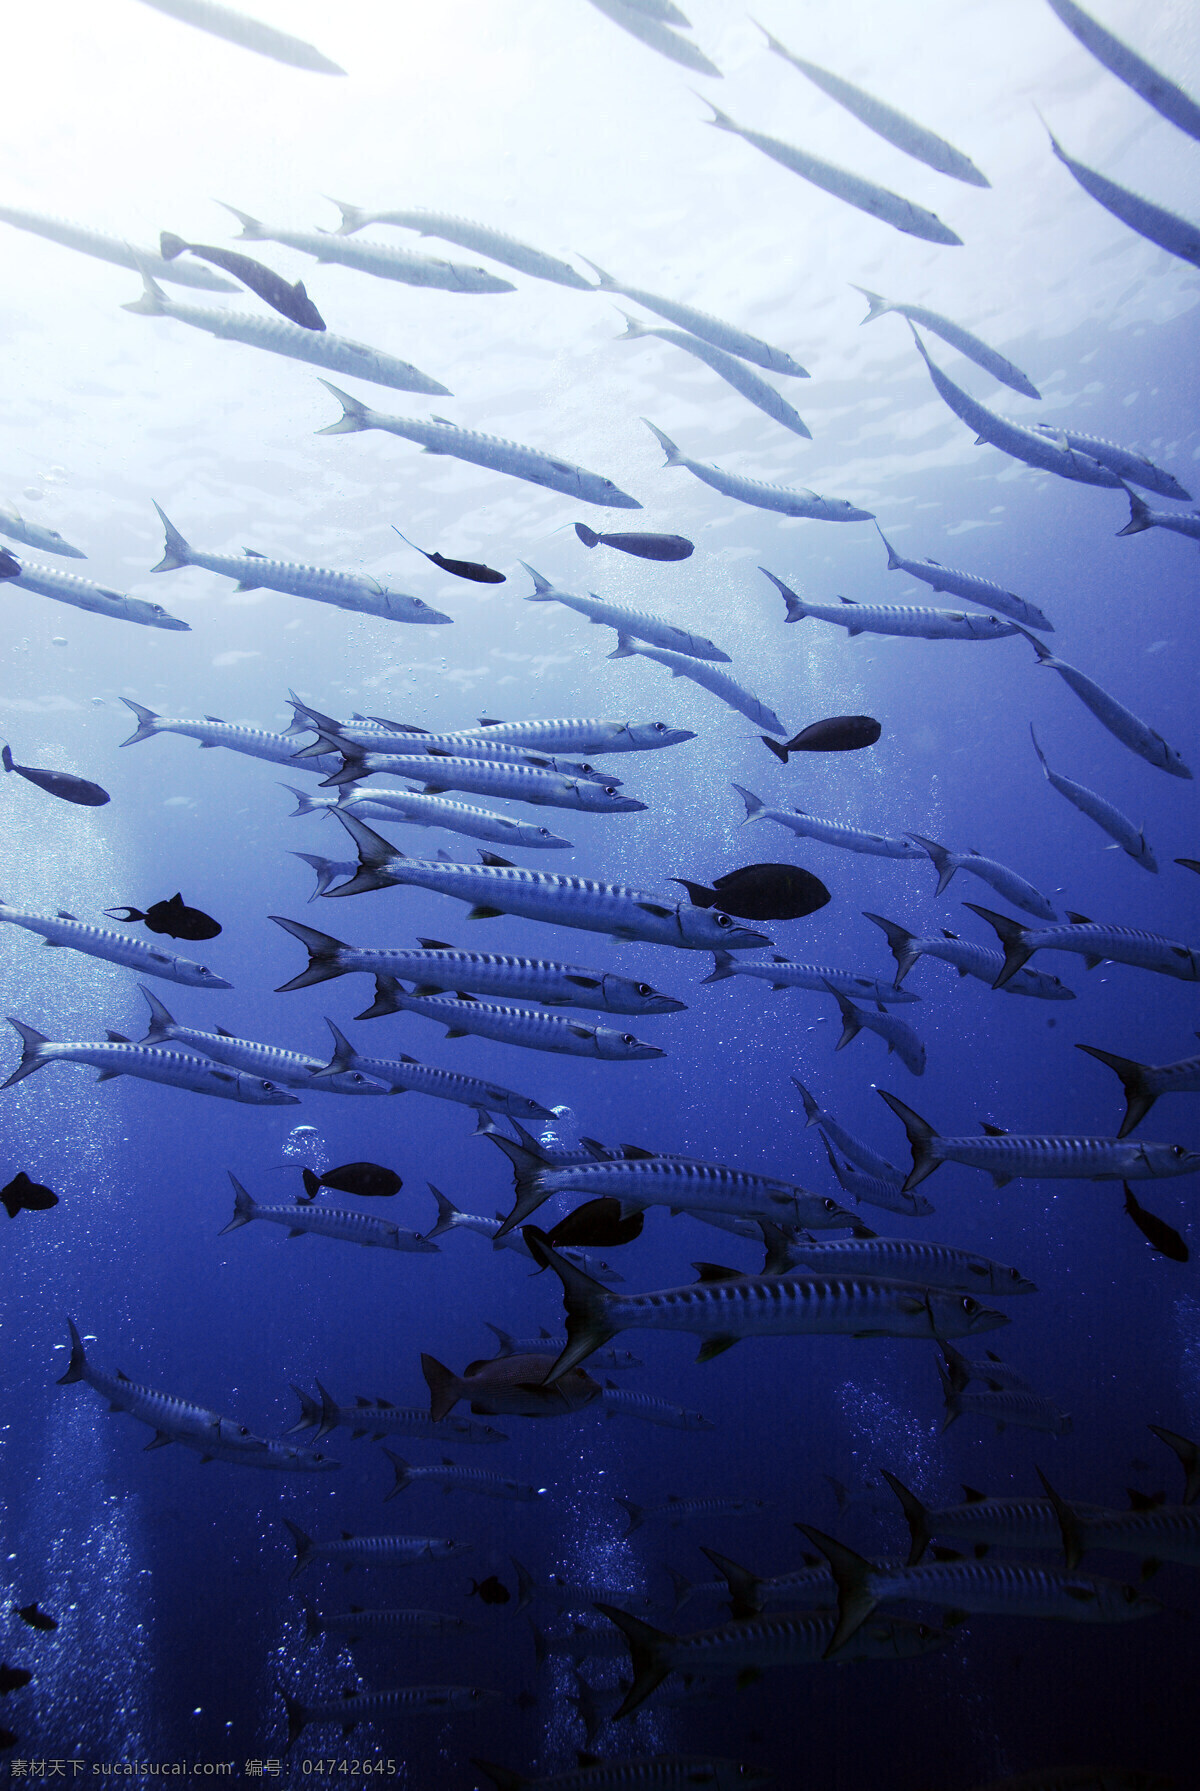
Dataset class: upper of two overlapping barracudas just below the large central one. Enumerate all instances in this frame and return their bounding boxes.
[269,913,686,1014]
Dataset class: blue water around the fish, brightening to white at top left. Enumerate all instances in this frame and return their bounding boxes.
[0,0,1200,1791]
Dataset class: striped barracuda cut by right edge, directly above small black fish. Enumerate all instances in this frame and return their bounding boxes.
[876,1089,1200,1189]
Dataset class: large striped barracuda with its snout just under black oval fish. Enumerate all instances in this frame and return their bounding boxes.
[322,813,770,951]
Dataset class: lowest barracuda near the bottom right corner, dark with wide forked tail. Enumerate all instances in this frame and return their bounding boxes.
[797,1524,1162,1655]
